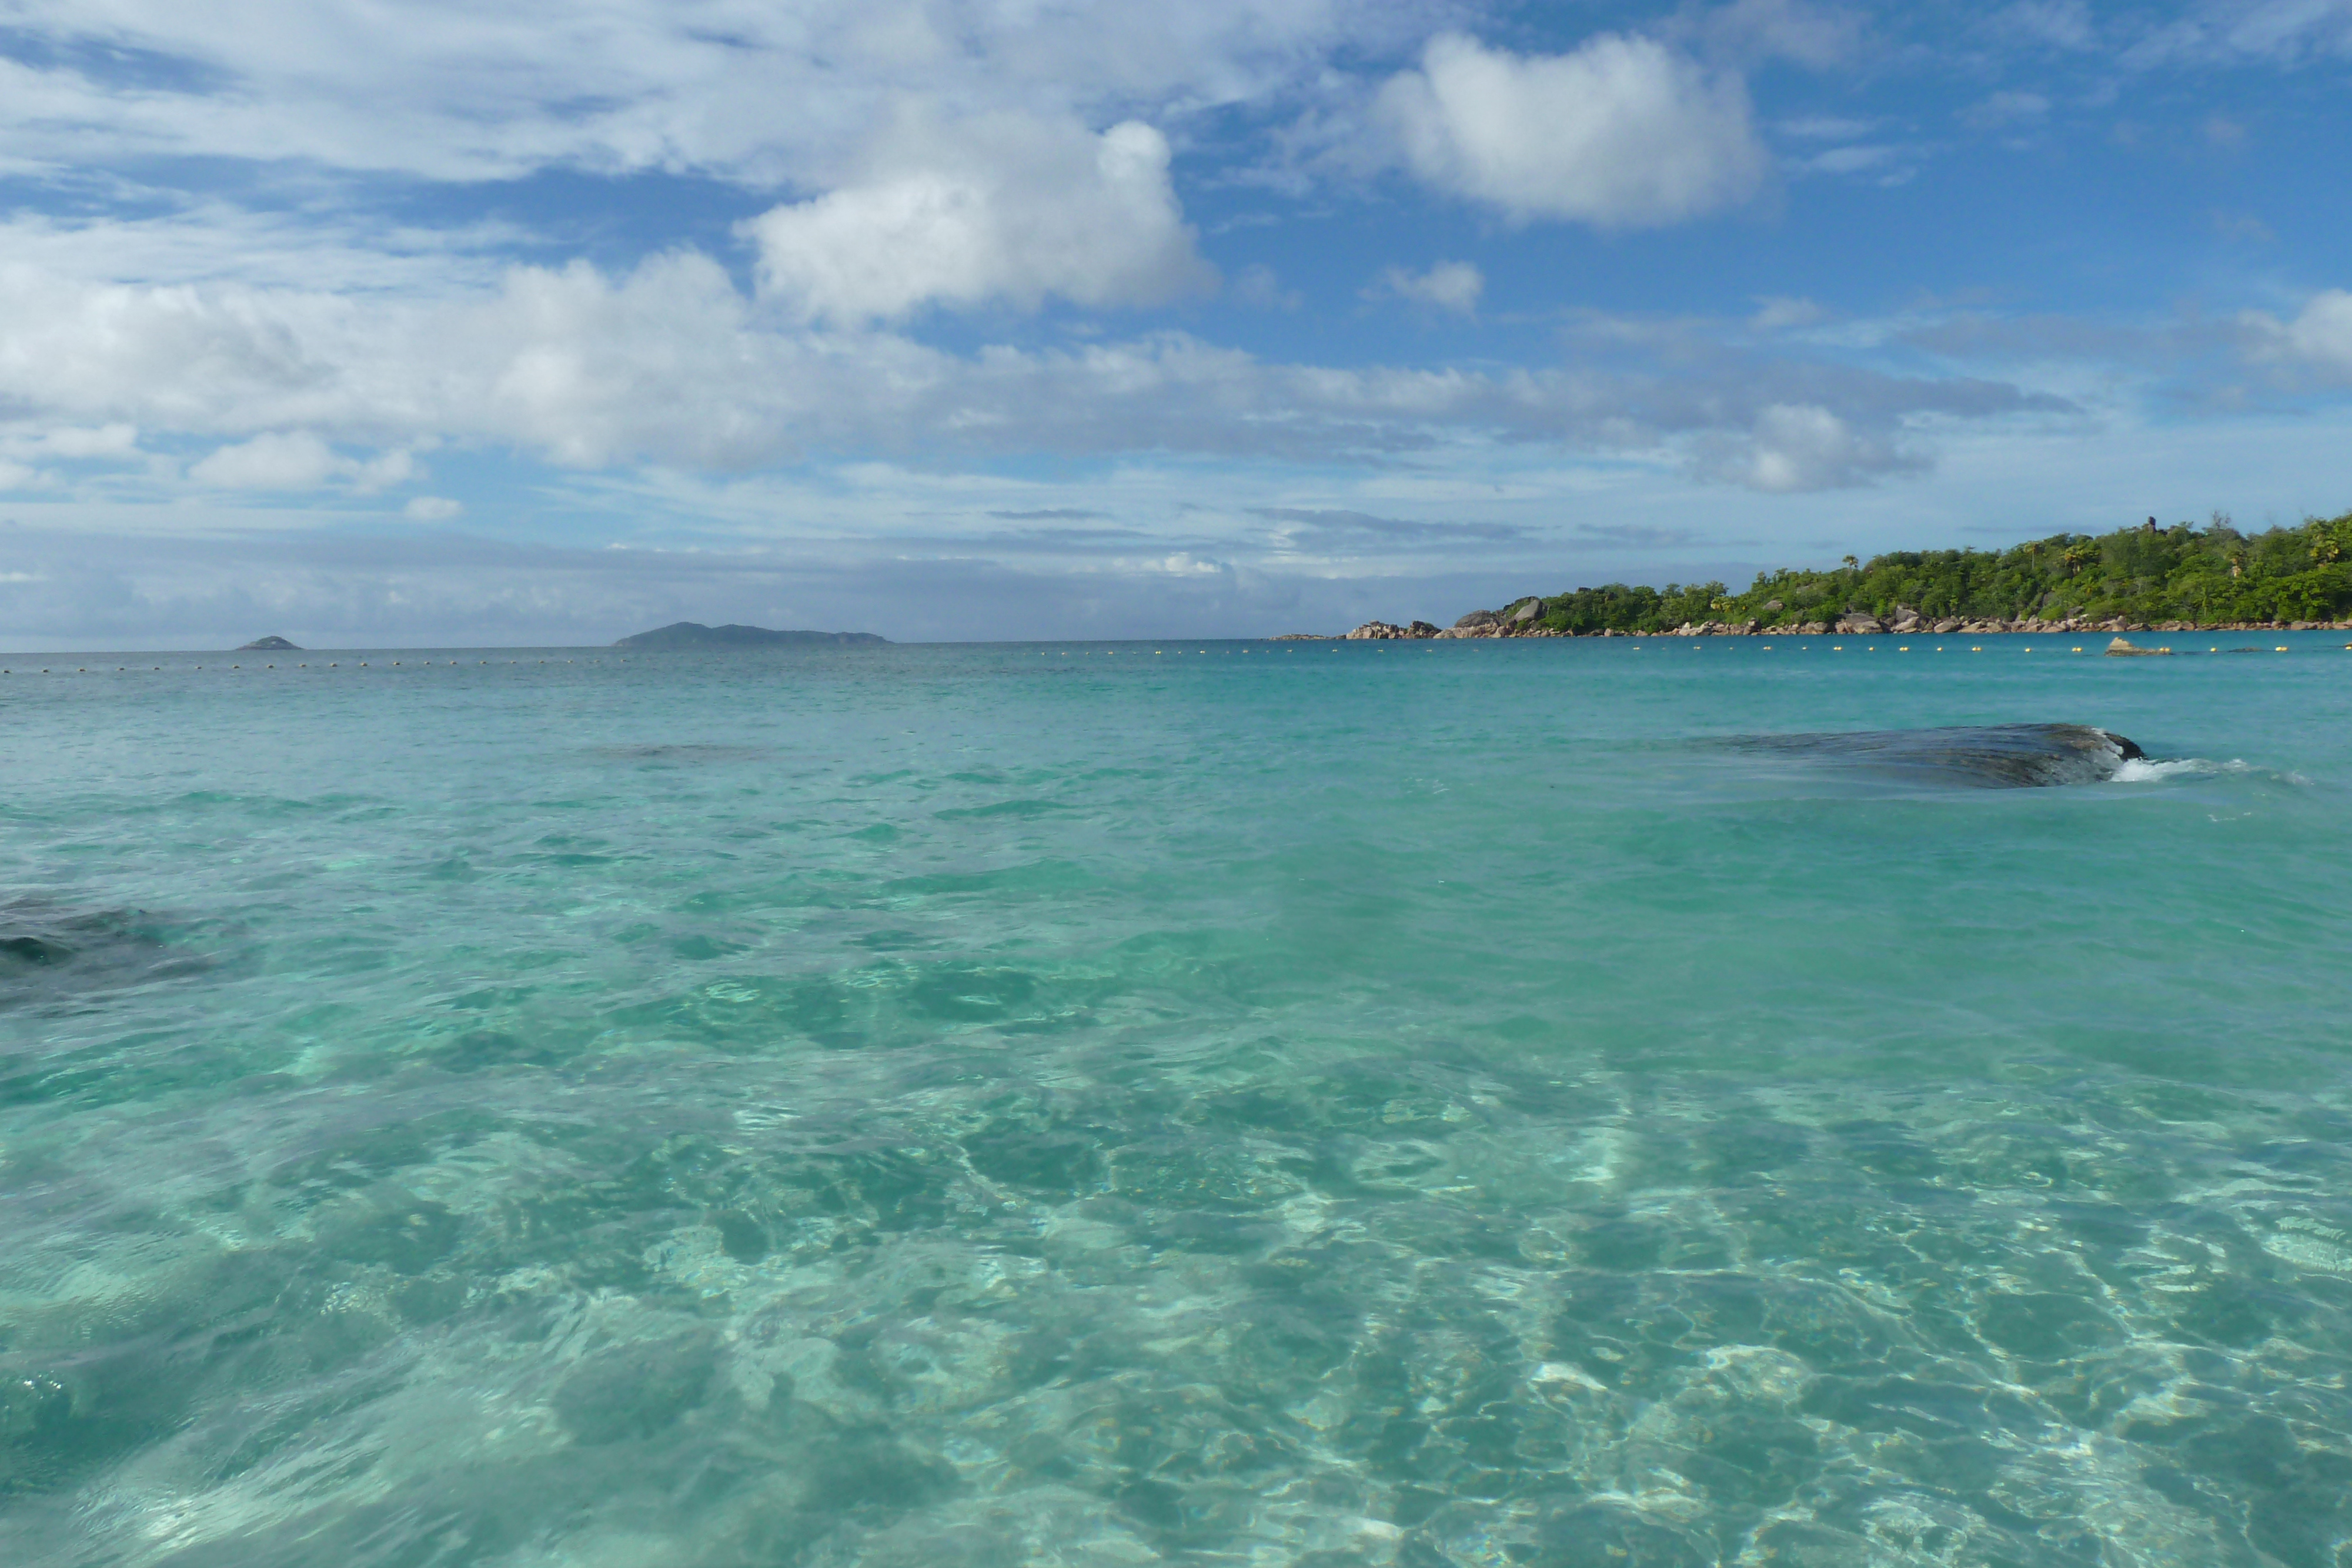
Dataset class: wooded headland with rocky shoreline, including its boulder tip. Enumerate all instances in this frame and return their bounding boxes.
[1348,513,2352,642]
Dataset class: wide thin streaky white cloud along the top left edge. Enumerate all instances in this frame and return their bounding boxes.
[0,0,1392,186]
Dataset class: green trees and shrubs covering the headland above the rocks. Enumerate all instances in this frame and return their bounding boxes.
[1505,513,2352,635]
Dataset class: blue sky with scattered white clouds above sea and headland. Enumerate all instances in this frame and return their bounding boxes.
[0,0,2352,649]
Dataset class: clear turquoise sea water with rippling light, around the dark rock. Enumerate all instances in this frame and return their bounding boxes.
[0,635,2352,1568]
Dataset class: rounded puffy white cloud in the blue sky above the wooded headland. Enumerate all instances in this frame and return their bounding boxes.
[1378,33,1766,228]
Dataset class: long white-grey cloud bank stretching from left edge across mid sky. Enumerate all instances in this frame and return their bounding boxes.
[0,252,2049,489]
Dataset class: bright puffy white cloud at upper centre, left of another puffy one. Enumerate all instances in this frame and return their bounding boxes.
[743,115,1216,322]
